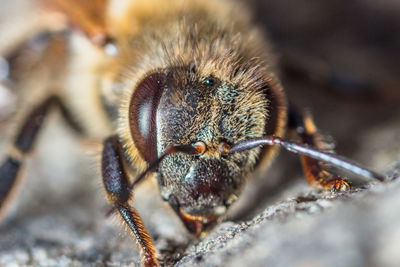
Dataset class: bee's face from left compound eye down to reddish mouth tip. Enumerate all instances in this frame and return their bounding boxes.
[130,65,268,234]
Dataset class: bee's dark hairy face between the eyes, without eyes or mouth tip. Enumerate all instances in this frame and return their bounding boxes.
[156,66,267,205]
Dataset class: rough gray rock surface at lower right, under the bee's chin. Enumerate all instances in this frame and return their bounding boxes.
[177,179,400,266]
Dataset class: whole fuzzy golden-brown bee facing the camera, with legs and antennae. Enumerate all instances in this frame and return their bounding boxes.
[0,0,384,266]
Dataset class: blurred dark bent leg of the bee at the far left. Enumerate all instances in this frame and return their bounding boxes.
[0,97,80,219]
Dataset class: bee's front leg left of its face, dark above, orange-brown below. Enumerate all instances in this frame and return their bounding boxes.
[101,136,158,266]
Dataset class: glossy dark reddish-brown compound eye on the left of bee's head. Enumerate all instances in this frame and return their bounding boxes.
[129,72,166,163]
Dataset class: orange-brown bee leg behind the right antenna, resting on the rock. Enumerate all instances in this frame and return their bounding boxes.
[289,107,350,191]
